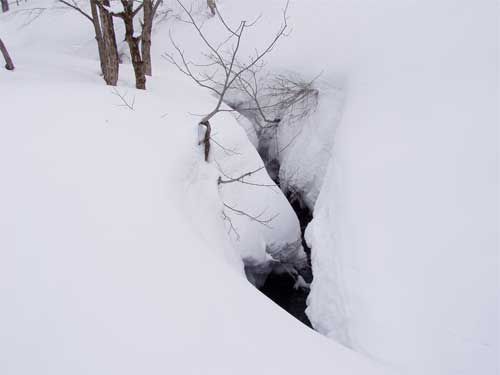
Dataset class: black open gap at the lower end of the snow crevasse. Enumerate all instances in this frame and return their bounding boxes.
[260,194,312,328]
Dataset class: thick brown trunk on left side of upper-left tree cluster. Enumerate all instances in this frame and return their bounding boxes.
[99,0,119,86]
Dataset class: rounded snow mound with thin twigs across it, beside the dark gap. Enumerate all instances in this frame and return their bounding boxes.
[208,110,306,285]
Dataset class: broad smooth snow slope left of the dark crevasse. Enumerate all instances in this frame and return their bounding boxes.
[0,1,389,375]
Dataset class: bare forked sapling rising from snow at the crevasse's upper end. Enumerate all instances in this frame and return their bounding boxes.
[164,0,288,161]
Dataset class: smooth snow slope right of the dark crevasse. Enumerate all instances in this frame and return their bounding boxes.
[179,0,500,374]
